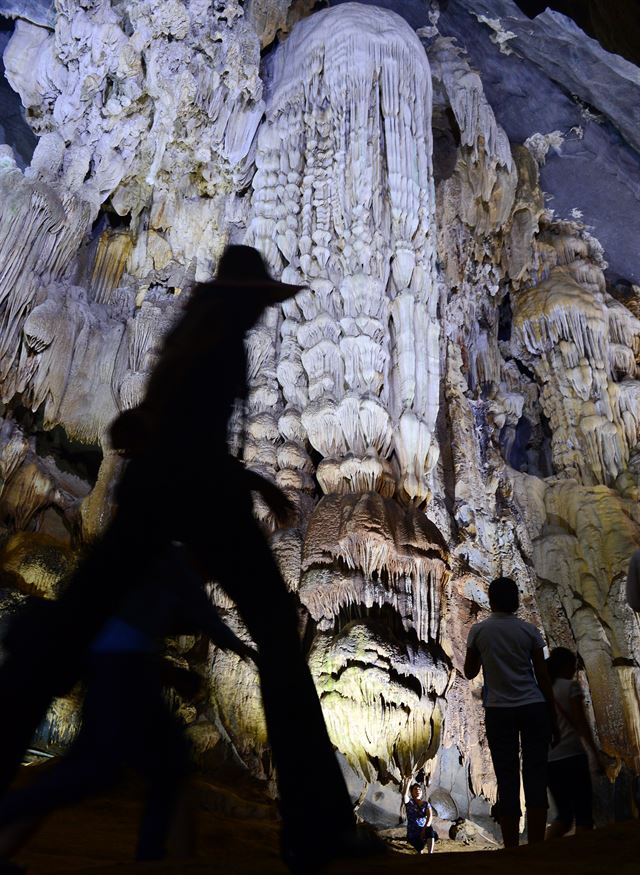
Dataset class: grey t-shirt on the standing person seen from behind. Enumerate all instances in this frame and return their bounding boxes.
[467,611,545,708]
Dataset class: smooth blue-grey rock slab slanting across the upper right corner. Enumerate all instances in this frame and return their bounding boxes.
[438,0,640,283]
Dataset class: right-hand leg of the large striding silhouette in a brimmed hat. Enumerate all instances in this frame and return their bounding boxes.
[189,494,354,855]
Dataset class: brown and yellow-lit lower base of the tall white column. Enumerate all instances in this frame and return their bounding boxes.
[300,493,452,782]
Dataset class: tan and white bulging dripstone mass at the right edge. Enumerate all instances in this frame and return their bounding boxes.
[513,224,640,484]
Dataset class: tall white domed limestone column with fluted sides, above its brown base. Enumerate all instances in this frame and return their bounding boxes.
[246,3,440,504]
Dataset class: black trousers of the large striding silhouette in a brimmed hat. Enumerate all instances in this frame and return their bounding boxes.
[0,458,354,844]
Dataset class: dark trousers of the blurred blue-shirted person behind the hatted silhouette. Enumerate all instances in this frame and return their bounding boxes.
[0,653,189,860]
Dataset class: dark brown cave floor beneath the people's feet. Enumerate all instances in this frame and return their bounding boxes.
[11,781,640,875]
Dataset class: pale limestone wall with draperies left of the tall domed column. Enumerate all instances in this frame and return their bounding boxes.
[0,0,263,452]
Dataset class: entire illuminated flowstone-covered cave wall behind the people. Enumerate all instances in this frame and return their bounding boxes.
[0,0,640,825]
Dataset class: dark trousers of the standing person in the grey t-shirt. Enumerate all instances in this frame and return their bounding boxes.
[485,702,551,817]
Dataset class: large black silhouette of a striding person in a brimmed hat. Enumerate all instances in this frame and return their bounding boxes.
[0,246,357,871]
